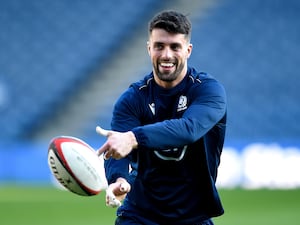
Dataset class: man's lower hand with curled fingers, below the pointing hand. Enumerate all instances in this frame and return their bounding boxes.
[106,177,131,208]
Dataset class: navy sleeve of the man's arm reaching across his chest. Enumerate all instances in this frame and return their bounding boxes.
[132,79,226,150]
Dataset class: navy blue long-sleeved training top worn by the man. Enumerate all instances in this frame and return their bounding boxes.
[105,68,226,225]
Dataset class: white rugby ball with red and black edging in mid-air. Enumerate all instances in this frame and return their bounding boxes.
[48,136,107,196]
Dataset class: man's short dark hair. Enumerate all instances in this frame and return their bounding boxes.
[149,10,192,39]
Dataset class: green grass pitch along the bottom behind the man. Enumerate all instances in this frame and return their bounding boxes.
[0,185,300,225]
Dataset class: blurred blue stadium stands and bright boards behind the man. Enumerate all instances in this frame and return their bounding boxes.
[0,0,300,192]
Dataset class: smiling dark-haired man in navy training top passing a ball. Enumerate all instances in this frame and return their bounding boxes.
[97,11,226,225]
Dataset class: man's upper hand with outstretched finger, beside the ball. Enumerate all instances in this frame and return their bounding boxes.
[96,126,138,159]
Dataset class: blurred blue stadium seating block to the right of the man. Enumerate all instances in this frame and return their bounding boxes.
[190,0,300,144]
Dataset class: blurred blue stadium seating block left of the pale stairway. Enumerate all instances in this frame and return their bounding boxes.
[0,0,161,142]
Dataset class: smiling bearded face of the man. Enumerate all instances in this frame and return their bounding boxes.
[148,29,192,87]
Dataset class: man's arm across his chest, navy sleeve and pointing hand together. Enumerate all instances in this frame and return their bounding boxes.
[101,79,226,160]
